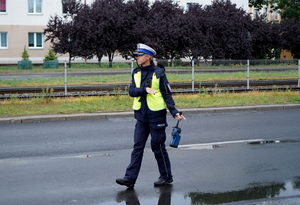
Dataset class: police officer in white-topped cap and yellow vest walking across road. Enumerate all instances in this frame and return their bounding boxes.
[116,44,186,188]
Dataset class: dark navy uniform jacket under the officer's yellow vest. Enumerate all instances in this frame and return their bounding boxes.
[129,64,179,122]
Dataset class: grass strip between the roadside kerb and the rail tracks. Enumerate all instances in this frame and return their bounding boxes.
[0,90,300,117]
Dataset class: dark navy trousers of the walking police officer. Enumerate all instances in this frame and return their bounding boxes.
[125,120,172,183]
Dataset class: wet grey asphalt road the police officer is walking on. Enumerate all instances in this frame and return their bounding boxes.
[0,109,300,205]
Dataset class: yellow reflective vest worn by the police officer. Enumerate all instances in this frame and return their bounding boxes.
[132,71,167,111]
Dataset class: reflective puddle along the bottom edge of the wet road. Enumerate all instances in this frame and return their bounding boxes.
[99,177,300,205]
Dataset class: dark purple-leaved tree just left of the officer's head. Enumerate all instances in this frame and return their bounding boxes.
[91,0,136,67]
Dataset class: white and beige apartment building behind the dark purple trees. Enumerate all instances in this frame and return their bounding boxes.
[0,0,248,64]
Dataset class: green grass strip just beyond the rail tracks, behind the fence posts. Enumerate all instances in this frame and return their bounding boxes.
[0,70,298,87]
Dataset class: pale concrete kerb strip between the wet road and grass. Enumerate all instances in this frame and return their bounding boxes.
[0,103,300,124]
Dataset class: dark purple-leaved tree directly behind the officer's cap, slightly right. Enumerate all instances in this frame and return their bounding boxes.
[143,0,188,65]
